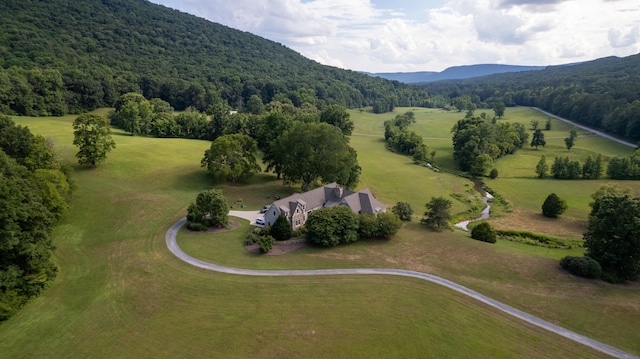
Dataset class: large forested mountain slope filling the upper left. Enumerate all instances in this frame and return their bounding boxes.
[0,0,428,115]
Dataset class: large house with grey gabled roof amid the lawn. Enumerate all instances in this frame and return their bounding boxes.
[264,182,387,230]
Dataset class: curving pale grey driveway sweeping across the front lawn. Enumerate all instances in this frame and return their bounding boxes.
[165,219,640,359]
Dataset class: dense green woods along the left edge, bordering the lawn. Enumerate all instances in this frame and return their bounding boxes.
[0,115,73,321]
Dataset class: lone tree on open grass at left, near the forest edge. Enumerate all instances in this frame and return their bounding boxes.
[73,113,116,167]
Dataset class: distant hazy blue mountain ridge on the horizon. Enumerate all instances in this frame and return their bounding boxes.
[366,64,545,84]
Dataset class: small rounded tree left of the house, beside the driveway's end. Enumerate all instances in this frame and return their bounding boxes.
[187,189,229,230]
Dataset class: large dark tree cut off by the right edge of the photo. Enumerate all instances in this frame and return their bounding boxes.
[584,194,640,280]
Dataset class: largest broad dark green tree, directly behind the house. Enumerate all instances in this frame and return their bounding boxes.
[272,122,361,190]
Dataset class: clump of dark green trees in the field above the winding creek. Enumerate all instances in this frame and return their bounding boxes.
[453,117,528,175]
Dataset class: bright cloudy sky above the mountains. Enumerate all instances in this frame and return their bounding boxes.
[151,0,640,72]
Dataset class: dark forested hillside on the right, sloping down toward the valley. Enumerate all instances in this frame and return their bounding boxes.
[423,55,640,141]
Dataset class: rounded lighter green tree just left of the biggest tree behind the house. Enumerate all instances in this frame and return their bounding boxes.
[200,134,260,182]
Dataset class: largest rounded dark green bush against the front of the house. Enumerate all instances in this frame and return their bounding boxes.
[305,206,359,247]
